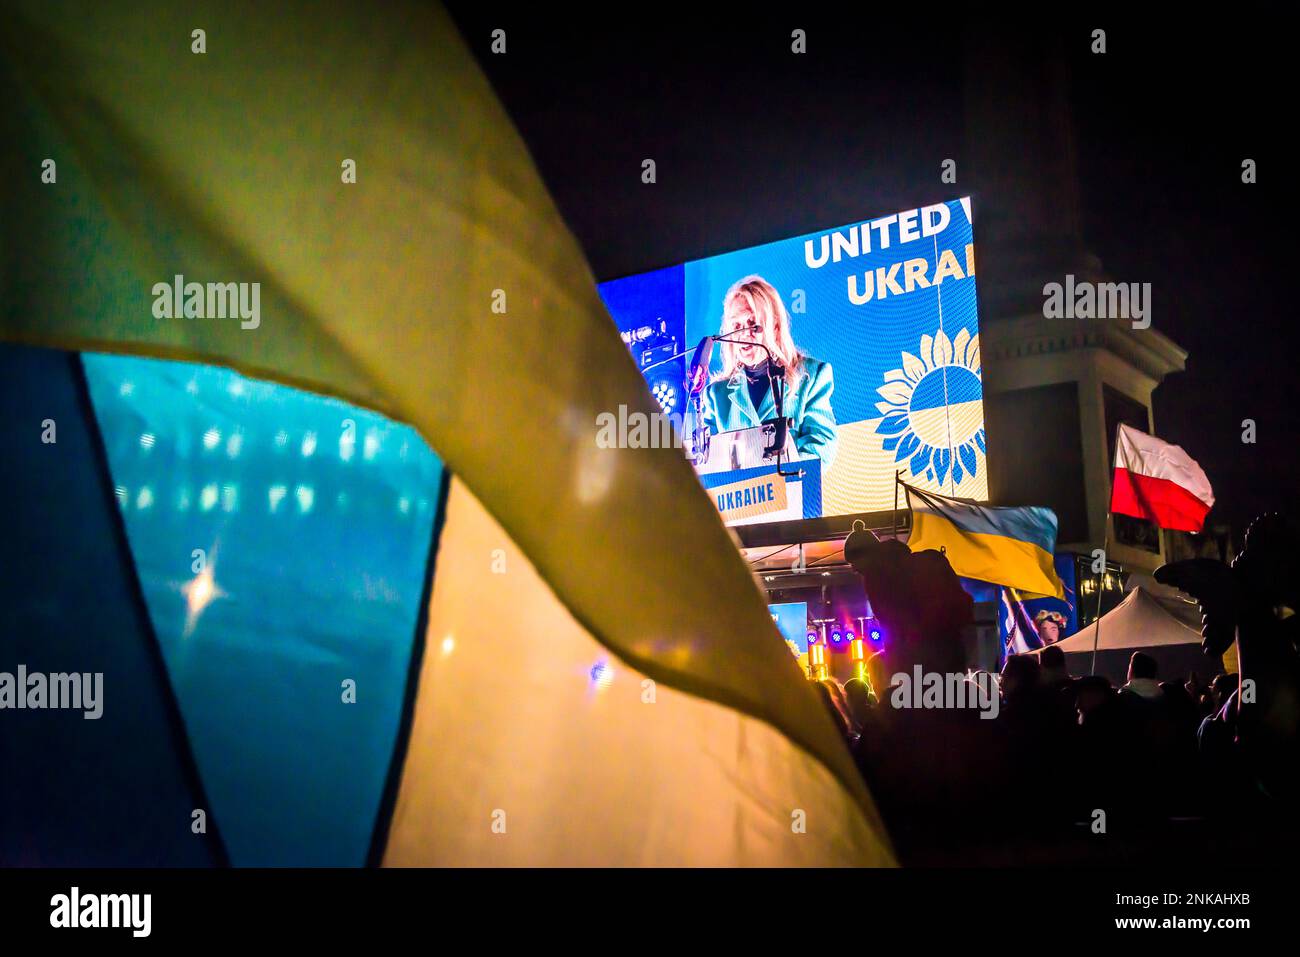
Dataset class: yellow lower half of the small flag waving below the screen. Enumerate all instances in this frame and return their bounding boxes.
[907,510,1065,598]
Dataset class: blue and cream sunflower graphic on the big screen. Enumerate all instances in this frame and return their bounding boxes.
[876,329,985,486]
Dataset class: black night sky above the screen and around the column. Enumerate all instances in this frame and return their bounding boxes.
[451,4,1300,536]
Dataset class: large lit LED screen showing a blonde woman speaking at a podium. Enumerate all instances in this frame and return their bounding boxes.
[601,198,988,524]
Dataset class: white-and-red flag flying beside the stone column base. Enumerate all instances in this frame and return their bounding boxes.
[1110,425,1214,532]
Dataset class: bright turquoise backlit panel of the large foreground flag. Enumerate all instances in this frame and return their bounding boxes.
[85,355,445,866]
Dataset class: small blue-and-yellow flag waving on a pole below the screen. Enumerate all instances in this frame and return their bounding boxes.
[904,484,1065,598]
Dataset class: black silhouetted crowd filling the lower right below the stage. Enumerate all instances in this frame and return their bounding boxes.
[815,515,1300,863]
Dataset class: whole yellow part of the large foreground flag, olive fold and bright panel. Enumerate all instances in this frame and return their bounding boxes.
[0,0,893,866]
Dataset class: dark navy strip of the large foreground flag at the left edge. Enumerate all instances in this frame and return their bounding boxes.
[0,346,224,867]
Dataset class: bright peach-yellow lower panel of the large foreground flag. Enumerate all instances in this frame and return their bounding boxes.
[384,480,892,866]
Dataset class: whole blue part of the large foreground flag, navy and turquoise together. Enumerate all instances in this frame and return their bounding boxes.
[0,348,443,866]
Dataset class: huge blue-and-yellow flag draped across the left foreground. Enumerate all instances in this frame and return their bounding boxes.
[0,0,893,866]
